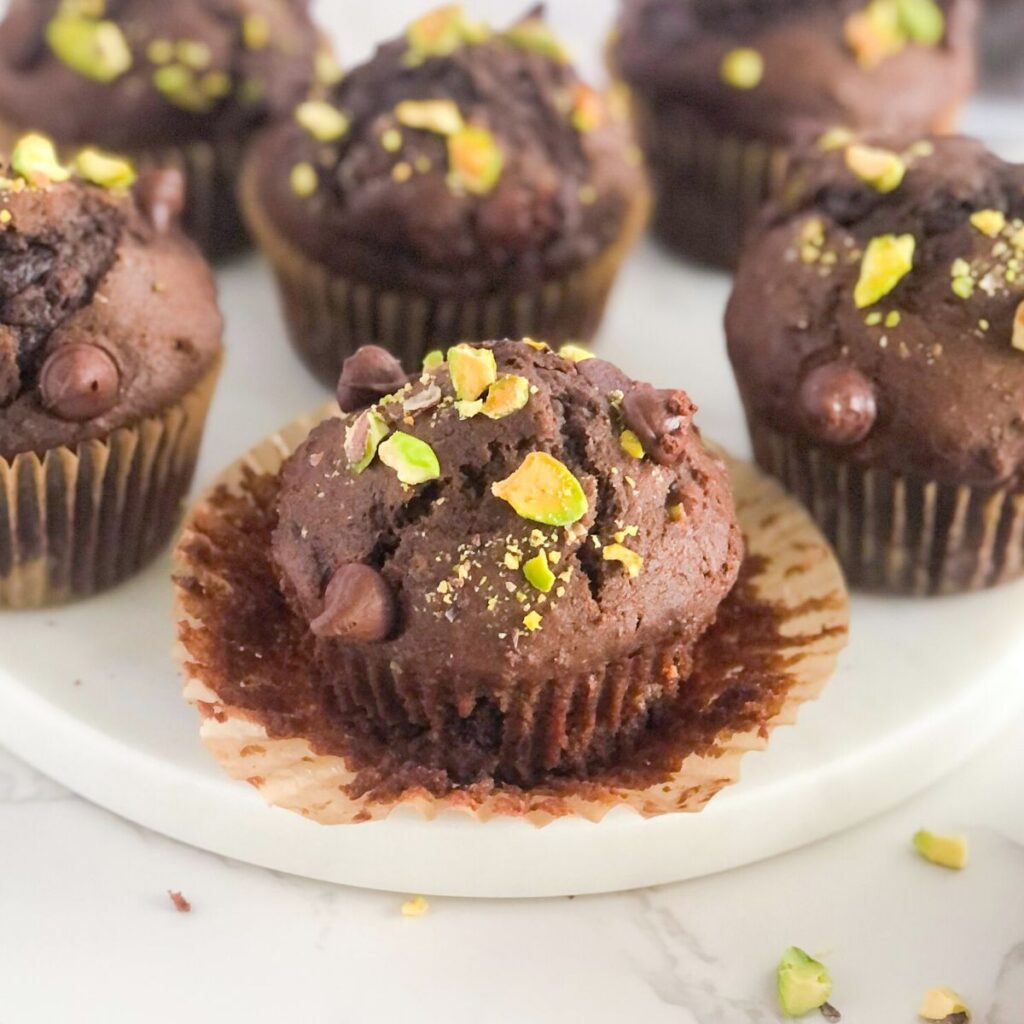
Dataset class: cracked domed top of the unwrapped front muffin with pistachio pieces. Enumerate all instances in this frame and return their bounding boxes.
[273,341,742,679]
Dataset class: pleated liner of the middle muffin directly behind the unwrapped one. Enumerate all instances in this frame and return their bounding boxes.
[241,165,649,388]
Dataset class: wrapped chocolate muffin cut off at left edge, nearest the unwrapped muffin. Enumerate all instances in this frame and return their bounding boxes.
[0,135,221,607]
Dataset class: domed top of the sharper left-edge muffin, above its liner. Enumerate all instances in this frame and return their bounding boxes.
[0,135,221,458]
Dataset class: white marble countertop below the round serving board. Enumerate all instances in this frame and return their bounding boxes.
[0,719,1024,1024]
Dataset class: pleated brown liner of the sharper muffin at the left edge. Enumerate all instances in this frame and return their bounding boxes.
[0,360,220,608]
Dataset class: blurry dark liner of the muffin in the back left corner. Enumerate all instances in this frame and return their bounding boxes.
[0,122,250,259]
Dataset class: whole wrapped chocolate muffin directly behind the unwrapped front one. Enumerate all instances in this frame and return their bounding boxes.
[243,5,646,385]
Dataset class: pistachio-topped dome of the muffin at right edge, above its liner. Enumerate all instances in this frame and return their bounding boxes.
[726,131,1024,486]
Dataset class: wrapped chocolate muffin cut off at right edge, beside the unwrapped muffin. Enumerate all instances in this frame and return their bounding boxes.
[726,137,1024,594]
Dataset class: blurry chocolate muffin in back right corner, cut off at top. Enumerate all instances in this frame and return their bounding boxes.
[609,0,977,267]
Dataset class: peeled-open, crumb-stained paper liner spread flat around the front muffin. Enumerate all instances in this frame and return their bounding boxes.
[175,407,848,825]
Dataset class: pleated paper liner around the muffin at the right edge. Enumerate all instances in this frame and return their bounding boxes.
[752,427,1024,597]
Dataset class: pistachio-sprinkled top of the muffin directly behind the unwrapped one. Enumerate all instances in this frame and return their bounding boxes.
[246,6,644,294]
